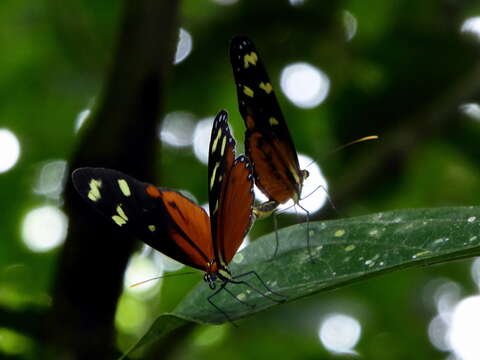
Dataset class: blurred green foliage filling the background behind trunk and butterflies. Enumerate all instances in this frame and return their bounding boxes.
[0,0,480,360]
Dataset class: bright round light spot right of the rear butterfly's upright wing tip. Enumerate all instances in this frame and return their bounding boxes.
[280,62,330,109]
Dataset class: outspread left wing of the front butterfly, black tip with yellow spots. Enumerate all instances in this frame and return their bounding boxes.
[72,168,213,270]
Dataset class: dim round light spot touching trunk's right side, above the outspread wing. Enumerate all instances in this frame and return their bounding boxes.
[160,111,195,147]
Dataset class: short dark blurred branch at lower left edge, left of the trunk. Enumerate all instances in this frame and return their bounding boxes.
[0,307,47,340]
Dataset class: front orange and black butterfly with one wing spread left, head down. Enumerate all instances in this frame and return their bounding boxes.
[72,111,282,319]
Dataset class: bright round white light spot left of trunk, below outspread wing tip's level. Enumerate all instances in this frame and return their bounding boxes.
[22,205,68,252]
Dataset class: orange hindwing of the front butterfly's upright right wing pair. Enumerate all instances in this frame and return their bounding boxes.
[214,155,255,265]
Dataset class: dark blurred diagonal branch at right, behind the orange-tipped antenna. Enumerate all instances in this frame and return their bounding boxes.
[313,62,480,220]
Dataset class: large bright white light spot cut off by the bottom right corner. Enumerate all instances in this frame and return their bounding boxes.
[449,296,480,360]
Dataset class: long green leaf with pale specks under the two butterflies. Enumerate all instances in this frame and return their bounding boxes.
[124,207,480,354]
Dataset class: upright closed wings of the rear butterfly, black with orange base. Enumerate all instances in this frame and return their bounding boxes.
[230,36,302,203]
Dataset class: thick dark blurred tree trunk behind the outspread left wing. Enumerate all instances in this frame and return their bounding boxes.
[45,0,178,359]
